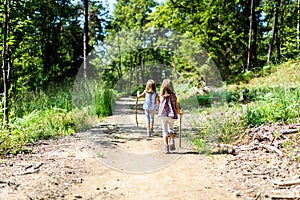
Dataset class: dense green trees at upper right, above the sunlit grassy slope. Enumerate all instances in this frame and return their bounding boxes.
[145,0,299,81]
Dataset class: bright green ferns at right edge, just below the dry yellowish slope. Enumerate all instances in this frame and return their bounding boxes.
[226,84,300,126]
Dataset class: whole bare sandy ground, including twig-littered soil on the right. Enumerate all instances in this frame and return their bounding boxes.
[0,96,300,200]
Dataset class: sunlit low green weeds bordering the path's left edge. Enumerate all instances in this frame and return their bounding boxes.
[0,108,91,154]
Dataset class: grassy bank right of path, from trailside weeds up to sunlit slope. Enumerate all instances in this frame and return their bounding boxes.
[190,60,300,152]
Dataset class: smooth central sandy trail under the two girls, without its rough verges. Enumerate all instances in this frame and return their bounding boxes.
[66,98,236,200]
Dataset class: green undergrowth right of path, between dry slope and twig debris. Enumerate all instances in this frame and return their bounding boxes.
[193,70,300,152]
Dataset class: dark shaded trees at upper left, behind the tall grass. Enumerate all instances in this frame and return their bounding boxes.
[0,0,106,121]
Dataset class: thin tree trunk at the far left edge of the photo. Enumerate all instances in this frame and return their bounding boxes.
[2,0,9,126]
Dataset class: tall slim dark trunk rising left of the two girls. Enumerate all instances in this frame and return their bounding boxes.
[83,0,89,78]
